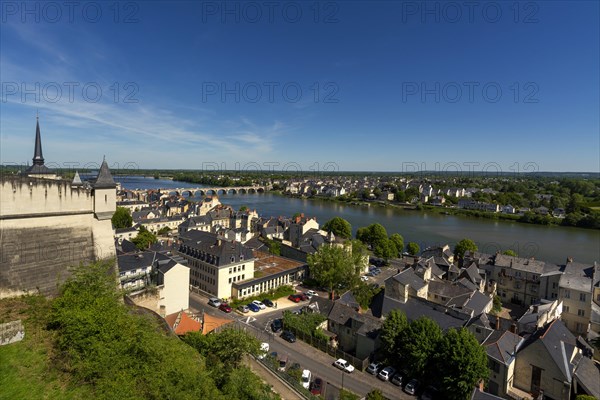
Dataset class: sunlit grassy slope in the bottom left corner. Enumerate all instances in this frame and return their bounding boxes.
[0,296,95,400]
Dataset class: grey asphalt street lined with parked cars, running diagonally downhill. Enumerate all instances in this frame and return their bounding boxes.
[190,293,415,399]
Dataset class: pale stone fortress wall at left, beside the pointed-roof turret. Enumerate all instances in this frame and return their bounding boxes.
[0,176,115,298]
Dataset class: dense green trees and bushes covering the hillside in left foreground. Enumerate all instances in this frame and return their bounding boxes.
[47,263,278,400]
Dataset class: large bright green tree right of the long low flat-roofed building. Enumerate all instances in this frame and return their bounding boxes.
[307,244,362,296]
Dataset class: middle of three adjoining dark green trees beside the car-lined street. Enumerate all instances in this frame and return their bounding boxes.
[397,317,443,377]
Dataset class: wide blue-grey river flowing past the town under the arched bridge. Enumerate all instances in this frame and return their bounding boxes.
[115,177,600,264]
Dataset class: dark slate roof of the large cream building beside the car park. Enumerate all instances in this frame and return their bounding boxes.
[178,230,253,267]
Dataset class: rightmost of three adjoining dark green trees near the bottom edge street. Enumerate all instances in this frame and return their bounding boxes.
[435,329,489,400]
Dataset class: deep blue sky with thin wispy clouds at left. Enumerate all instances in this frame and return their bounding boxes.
[0,1,600,172]
